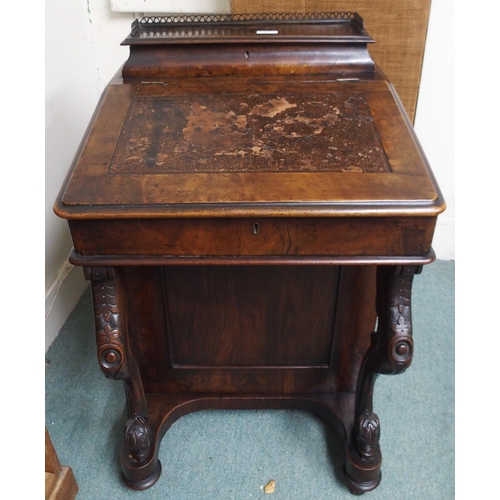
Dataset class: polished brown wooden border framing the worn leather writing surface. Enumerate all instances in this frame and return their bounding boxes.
[56,77,444,218]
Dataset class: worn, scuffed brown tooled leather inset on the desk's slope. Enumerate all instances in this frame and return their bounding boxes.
[108,92,391,174]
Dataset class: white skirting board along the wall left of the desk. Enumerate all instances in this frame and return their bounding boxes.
[45,263,89,352]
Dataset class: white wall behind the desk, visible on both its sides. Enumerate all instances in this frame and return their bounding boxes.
[45,0,455,348]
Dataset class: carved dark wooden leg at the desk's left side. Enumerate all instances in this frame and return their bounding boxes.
[84,267,161,489]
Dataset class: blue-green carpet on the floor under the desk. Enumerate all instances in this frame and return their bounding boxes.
[45,261,455,500]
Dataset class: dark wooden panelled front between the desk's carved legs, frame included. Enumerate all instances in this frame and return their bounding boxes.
[119,266,376,395]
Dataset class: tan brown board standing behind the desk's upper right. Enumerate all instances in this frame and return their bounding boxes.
[231,0,431,122]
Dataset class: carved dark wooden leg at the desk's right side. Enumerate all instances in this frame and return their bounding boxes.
[344,266,422,495]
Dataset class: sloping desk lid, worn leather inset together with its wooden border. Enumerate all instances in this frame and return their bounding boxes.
[55,77,441,217]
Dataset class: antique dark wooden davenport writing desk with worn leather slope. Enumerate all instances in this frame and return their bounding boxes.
[55,13,444,493]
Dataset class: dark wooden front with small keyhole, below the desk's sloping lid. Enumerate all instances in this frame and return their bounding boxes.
[70,217,436,257]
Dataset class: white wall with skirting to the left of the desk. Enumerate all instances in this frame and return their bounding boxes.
[45,0,134,349]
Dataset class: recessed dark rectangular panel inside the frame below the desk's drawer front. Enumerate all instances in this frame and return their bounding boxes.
[163,266,338,368]
